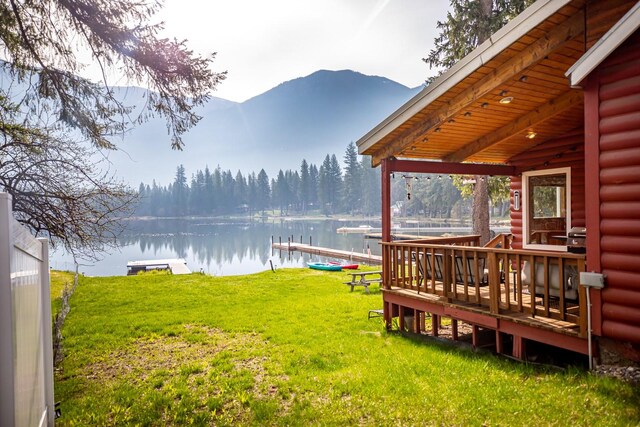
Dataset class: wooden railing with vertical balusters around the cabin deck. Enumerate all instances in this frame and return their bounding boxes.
[382,241,587,336]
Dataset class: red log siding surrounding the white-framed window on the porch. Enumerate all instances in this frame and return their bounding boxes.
[509,133,585,249]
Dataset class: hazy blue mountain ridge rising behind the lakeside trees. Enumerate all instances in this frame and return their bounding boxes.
[103,70,420,186]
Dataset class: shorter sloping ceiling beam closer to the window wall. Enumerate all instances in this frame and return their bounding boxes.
[442,90,583,162]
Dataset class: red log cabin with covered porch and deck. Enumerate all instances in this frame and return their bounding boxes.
[357,0,640,363]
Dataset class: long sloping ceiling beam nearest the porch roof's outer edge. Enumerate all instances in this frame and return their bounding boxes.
[371,10,584,165]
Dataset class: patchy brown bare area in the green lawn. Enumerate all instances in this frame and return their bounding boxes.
[83,325,289,425]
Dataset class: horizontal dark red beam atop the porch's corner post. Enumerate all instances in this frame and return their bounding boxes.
[385,159,518,176]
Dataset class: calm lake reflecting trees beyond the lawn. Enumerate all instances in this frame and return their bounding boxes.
[51,218,478,276]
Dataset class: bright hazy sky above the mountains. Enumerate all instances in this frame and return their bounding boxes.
[159,0,449,101]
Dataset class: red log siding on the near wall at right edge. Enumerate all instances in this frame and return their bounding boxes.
[585,32,640,344]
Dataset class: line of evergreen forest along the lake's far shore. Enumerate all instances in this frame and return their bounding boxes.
[132,143,490,218]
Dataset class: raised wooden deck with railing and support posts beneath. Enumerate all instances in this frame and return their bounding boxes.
[382,237,588,358]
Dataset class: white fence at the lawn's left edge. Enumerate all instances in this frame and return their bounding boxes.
[0,193,55,427]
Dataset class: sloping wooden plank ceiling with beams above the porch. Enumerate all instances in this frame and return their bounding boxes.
[358,2,585,169]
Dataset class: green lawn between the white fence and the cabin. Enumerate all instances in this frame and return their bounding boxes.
[55,269,640,426]
